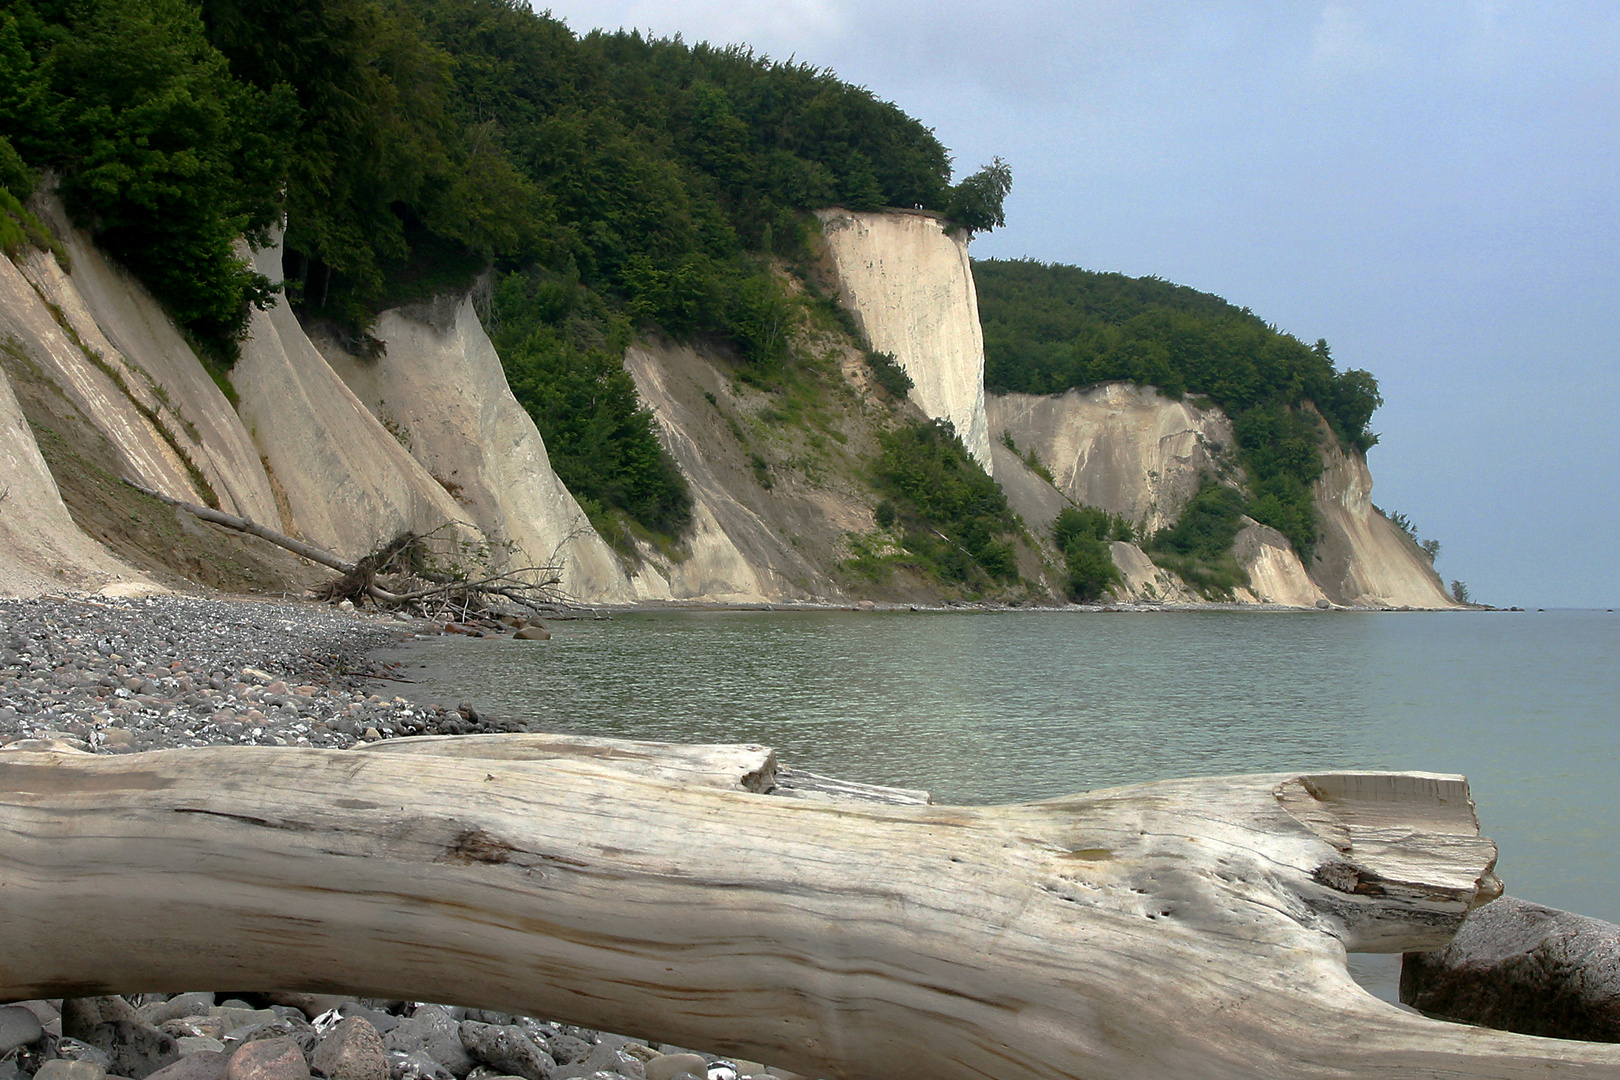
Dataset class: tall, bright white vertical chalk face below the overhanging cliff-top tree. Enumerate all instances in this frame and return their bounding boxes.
[816,209,990,471]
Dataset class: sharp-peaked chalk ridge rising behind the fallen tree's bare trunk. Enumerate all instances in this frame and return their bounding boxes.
[230,233,476,559]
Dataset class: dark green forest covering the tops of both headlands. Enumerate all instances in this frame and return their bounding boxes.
[0,0,1379,592]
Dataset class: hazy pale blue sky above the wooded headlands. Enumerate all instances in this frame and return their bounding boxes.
[538,0,1620,609]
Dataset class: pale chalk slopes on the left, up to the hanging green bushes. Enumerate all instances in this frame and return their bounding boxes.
[0,210,640,602]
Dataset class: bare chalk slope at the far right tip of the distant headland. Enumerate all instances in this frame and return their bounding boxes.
[1311,447,1456,607]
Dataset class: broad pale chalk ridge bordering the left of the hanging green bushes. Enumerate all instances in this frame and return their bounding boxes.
[318,296,637,604]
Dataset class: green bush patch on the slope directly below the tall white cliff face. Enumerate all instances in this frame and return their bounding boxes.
[878,419,1017,586]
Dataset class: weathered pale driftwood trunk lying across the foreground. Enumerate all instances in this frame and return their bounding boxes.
[0,737,1620,1080]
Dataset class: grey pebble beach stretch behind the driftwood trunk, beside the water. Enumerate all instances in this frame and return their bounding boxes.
[0,596,520,753]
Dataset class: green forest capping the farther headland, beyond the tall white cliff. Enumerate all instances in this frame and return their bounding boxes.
[974,259,1382,563]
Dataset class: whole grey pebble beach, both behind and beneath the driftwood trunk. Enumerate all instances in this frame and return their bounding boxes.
[0,596,800,1080]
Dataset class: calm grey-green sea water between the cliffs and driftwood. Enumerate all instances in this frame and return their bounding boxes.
[385,612,1620,921]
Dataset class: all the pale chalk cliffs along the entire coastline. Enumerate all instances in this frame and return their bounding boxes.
[0,201,1452,607]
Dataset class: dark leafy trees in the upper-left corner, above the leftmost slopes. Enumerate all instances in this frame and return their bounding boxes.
[0,0,295,351]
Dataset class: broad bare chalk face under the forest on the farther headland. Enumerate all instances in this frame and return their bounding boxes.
[985,382,1234,533]
